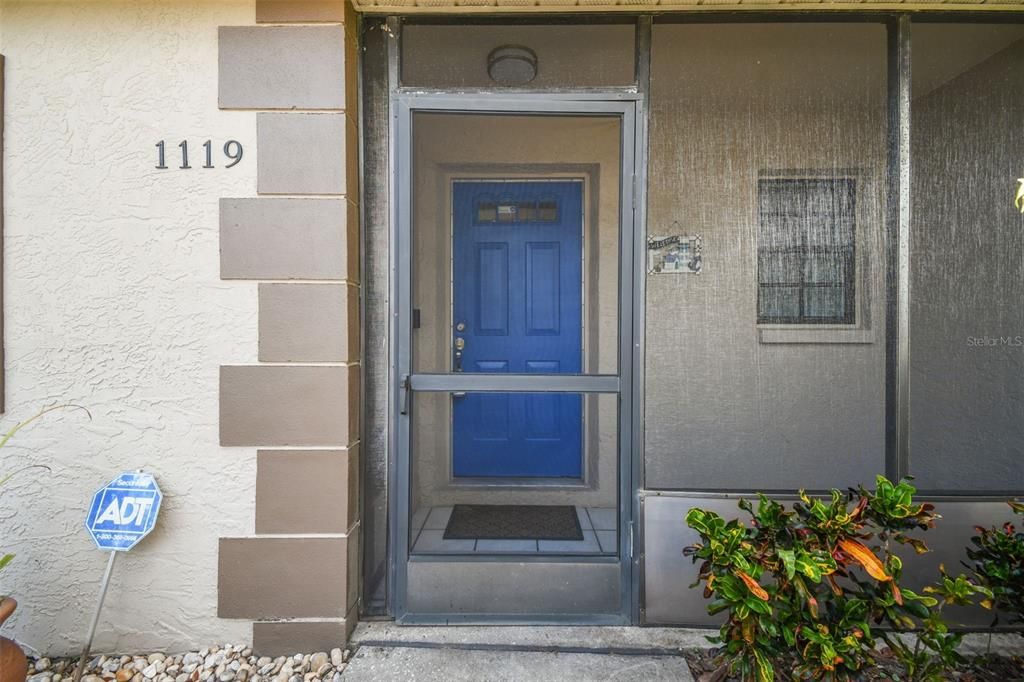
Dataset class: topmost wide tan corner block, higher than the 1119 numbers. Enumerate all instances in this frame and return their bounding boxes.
[217,25,345,109]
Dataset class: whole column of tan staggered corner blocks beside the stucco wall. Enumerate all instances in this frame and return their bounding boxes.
[218,0,360,655]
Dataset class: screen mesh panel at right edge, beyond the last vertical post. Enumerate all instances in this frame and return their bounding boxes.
[910,24,1024,492]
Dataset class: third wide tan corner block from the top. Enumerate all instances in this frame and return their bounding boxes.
[220,366,358,446]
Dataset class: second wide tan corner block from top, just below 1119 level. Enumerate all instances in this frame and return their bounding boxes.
[220,199,359,281]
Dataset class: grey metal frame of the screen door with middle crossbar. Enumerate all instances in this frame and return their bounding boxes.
[388,88,646,625]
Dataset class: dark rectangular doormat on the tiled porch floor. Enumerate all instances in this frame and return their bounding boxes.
[444,505,583,540]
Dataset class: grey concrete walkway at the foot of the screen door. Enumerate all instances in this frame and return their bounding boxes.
[342,623,710,682]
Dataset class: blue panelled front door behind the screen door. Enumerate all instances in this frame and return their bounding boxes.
[452,180,583,478]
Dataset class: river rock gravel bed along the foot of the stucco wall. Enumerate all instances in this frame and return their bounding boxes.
[27,644,351,682]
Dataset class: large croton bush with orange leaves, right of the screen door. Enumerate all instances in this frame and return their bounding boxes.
[683,476,990,681]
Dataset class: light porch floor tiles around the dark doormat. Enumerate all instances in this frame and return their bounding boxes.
[411,506,617,555]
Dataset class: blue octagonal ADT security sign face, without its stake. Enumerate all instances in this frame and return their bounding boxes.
[85,471,163,552]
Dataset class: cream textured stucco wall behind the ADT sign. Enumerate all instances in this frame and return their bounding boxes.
[0,0,257,653]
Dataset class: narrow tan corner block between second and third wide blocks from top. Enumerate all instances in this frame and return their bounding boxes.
[259,284,359,363]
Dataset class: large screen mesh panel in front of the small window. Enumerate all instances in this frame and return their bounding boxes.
[644,24,888,489]
